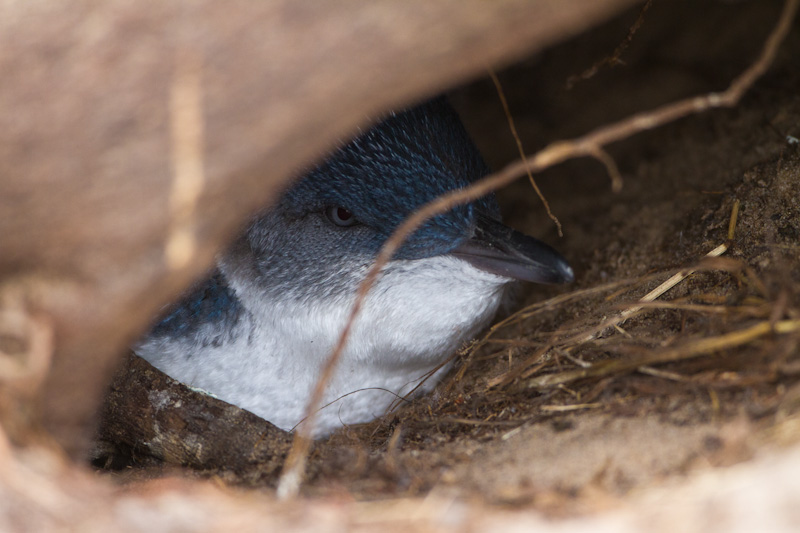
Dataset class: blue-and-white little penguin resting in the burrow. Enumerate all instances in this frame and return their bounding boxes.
[134,97,573,438]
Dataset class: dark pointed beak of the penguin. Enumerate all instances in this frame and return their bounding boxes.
[450,213,575,283]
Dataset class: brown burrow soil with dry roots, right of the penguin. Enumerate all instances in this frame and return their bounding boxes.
[98,0,800,516]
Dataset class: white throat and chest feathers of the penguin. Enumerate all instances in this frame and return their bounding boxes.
[136,256,509,437]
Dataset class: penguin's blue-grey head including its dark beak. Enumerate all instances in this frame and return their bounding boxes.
[228,98,572,302]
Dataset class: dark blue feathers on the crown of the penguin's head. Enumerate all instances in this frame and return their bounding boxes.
[281,98,499,259]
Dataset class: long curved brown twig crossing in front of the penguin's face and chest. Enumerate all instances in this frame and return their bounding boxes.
[278,0,800,498]
